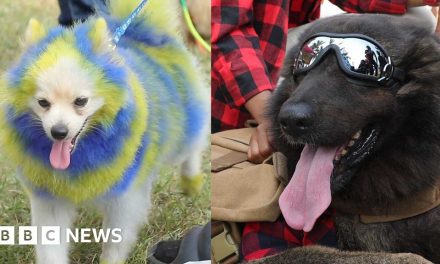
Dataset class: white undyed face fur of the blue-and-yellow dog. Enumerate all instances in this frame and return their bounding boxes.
[29,57,104,139]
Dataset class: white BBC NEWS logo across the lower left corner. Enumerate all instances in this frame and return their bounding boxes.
[0,226,122,245]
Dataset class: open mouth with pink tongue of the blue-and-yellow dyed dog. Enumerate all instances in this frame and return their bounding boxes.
[49,120,87,170]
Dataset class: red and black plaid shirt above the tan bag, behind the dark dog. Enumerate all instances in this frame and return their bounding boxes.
[211,0,406,132]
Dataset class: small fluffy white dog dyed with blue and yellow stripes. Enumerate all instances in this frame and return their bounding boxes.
[0,0,209,264]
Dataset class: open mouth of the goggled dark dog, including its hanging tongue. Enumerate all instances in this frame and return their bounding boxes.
[279,125,379,232]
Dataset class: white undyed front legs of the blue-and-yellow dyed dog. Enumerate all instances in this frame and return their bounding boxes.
[30,175,156,264]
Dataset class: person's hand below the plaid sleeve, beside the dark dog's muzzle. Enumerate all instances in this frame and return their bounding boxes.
[245,91,272,163]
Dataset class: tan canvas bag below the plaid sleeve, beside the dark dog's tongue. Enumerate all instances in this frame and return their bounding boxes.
[211,128,285,222]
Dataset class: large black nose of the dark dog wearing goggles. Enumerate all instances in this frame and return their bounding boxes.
[278,102,313,135]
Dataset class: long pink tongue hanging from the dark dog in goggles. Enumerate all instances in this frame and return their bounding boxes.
[279,145,337,232]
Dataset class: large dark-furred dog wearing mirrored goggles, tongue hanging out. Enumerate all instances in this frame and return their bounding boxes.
[260,14,440,263]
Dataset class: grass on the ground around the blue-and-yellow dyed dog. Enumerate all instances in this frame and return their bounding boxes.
[0,0,210,264]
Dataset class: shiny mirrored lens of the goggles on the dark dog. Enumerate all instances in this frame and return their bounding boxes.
[294,36,388,78]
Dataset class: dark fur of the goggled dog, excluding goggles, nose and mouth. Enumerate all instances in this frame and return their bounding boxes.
[263,15,440,263]
